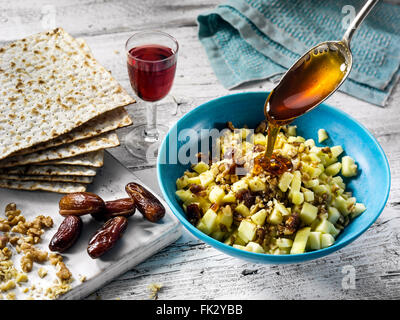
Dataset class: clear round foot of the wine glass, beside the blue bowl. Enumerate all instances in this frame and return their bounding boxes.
[124,124,169,164]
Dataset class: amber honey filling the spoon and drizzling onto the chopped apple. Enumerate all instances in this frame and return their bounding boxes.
[255,42,348,174]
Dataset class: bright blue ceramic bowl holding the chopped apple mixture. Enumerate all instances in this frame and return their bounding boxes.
[157,92,390,264]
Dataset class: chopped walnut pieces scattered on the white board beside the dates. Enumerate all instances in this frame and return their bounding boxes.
[0,203,77,300]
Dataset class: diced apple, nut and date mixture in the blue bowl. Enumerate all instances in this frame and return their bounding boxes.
[176,124,366,254]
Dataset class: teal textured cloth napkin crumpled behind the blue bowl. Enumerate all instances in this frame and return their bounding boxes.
[198,0,400,106]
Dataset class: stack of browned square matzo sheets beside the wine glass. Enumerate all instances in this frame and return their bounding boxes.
[0,29,135,193]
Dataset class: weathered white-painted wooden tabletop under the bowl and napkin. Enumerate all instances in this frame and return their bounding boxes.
[0,0,400,299]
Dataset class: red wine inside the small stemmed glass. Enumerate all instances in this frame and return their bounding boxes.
[128,44,176,101]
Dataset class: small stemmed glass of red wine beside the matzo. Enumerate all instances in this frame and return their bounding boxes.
[125,31,179,164]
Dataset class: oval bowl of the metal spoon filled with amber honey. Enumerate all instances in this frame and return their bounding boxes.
[264,41,353,124]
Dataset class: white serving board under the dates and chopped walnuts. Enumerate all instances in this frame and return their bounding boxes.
[0,152,181,299]
